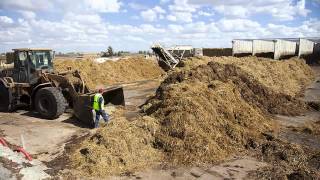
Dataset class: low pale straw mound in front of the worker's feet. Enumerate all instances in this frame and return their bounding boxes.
[71,109,162,177]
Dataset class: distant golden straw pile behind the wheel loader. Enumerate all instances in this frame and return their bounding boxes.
[54,56,163,89]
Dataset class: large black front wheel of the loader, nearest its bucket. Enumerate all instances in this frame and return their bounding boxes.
[34,87,66,119]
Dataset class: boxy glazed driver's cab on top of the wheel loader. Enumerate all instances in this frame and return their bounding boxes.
[13,48,54,84]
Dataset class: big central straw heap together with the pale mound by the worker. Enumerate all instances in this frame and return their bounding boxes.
[72,59,312,176]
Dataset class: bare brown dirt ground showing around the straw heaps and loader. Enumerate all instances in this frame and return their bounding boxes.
[0,61,320,179]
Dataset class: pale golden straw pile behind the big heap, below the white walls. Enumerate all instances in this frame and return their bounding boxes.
[184,56,314,96]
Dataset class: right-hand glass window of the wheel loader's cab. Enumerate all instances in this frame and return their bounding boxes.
[29,51,53,69]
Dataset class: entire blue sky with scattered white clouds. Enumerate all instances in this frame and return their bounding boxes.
[0,0,320,52]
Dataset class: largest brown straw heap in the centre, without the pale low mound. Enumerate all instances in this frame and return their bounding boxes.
[144,59,312,165]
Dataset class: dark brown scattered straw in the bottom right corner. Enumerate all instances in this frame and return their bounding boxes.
[248,139,320,180]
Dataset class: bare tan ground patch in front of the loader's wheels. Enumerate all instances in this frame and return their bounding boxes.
[0,110,89,161]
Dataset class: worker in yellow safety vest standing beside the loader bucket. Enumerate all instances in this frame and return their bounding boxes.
[93,89,109,128]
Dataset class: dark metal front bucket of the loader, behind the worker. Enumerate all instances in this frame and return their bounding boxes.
[73,87,125,127]
